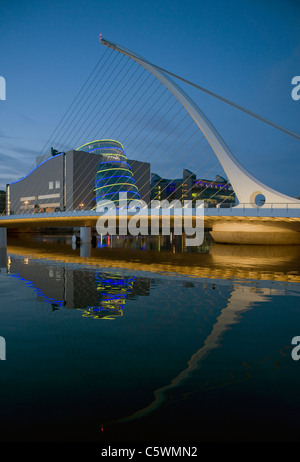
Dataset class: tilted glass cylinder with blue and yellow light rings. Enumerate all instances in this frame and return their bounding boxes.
[77,140,140,208]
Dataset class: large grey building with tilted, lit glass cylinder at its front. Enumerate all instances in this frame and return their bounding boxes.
[7,140,150,214]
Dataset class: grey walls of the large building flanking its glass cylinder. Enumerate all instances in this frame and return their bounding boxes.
[7,140,150,214]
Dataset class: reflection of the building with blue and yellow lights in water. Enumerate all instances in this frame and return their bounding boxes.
[7,255,150,320]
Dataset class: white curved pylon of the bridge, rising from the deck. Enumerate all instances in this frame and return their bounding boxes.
[100,35,300,208]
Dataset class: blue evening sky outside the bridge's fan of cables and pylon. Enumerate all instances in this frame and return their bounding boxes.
[0,0,300,195]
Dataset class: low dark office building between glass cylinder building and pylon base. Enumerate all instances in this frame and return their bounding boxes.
[151,169,235,207]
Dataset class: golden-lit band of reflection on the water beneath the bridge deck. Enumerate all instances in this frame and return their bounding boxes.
[8,235,300,282]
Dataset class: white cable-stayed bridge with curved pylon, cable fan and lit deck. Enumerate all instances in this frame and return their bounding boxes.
[0,36,300,247]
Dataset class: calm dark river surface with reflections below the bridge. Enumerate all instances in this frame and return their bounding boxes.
[0,235,300,442]
